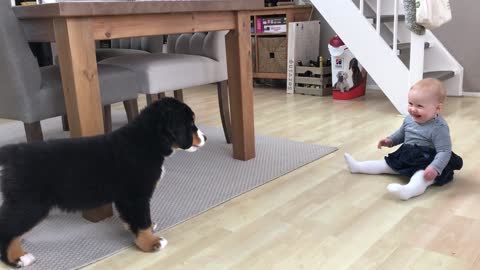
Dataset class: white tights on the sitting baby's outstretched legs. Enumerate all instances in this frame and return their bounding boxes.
[345,153,434,201]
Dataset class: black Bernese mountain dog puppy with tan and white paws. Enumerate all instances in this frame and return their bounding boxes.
[0,98,207,267]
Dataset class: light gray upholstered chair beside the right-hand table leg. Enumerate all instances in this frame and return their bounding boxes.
[100,31,231,143]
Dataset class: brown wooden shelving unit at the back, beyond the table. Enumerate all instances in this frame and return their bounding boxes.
[250,5,312,79]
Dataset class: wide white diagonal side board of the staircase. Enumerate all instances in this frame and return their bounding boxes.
[310,0,409,114]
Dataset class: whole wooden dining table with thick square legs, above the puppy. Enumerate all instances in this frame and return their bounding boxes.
[13,0,263,221]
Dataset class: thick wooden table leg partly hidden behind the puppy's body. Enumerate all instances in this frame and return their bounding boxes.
[54,17,112,222]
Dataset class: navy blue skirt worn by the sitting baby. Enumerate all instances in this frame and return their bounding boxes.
[385,144,463,186]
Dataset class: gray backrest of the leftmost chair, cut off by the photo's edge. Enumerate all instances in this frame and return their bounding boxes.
[0,0,41,120]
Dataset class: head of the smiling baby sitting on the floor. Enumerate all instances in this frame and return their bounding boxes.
[408,88,441,124]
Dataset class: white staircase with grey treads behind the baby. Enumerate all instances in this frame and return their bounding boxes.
[310,0,463,115]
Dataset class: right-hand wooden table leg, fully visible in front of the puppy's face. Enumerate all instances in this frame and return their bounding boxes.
[226,11,255,160]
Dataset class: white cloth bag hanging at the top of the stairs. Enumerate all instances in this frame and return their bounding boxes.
[415,0,452,29]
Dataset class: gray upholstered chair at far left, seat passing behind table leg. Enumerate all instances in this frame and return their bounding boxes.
[0,1,138,141]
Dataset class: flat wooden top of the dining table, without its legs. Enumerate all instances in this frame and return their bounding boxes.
[12,0,264,19]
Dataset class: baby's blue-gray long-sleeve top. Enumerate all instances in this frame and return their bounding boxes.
[388,115,452,175]
